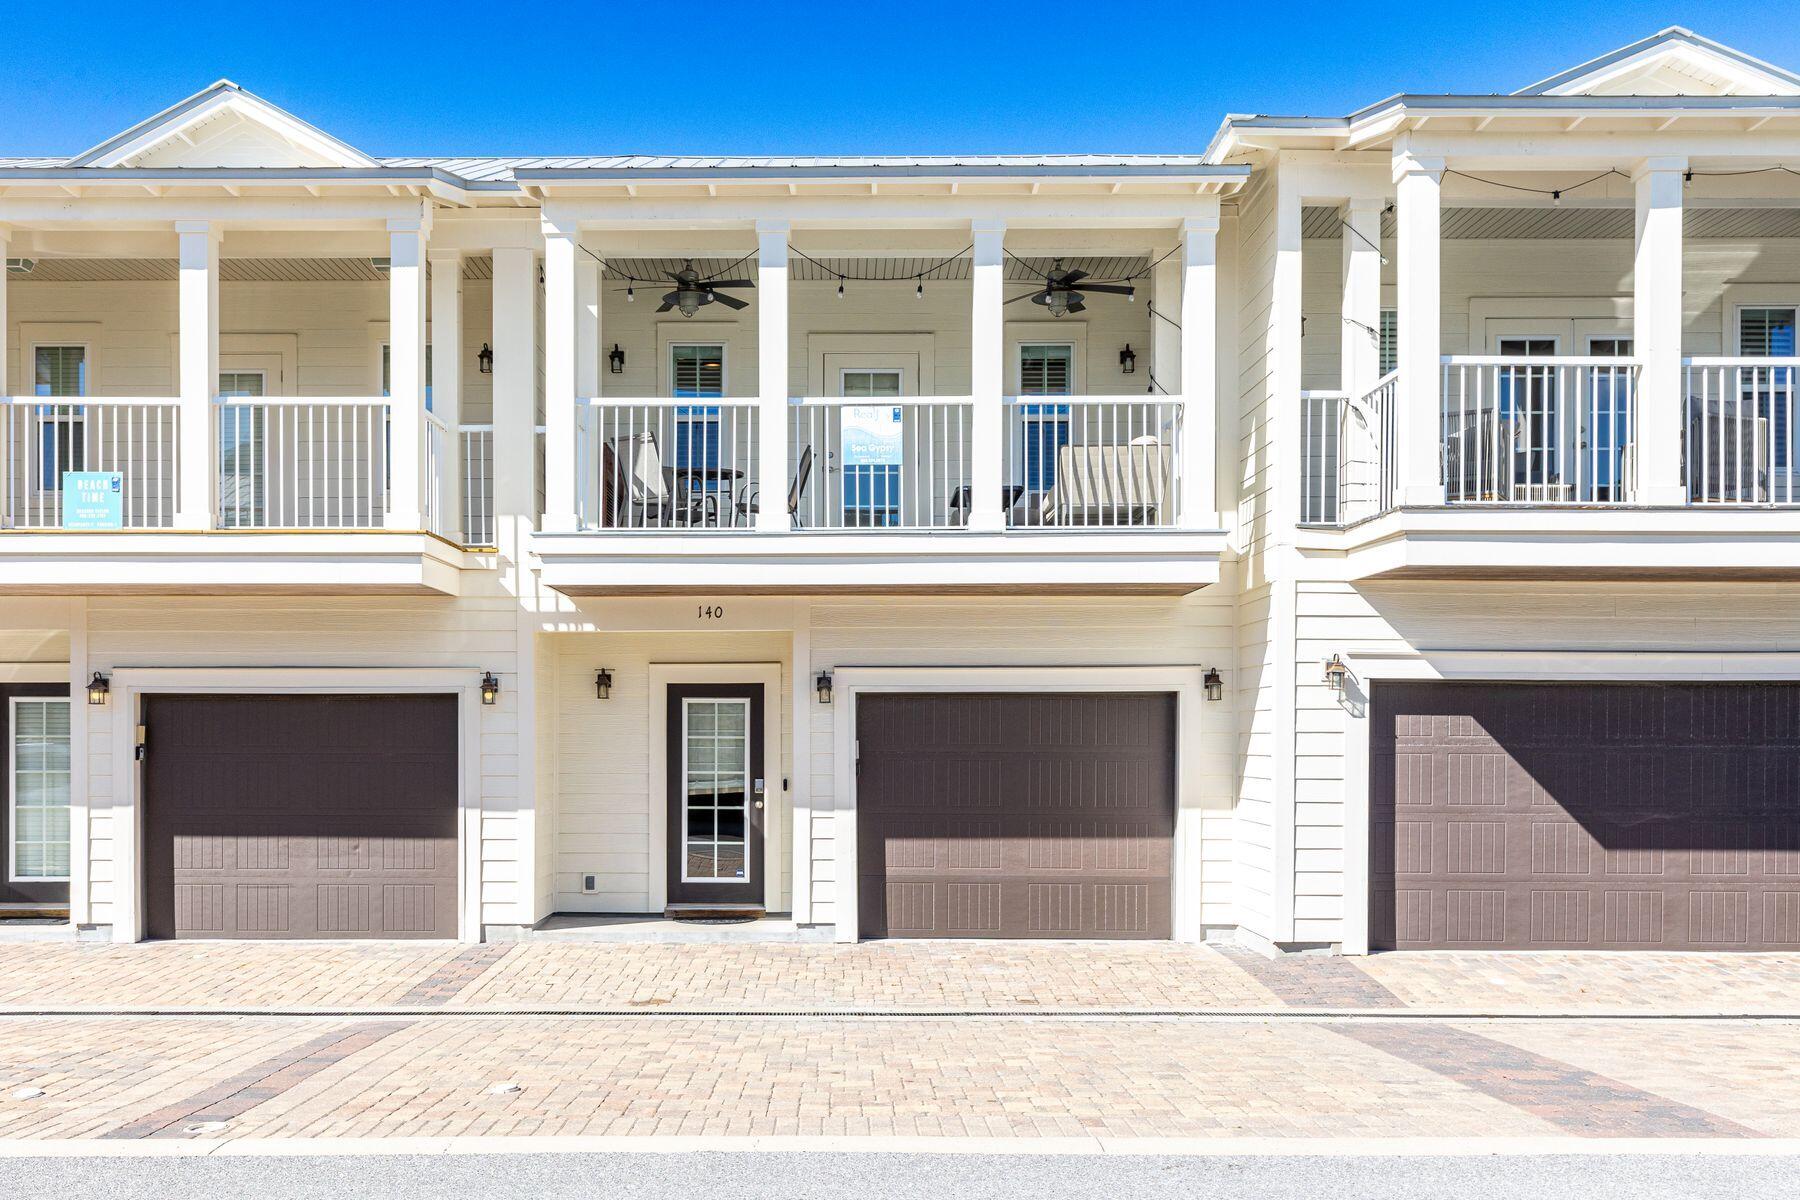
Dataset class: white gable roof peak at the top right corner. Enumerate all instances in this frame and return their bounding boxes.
[1514,25,1800,95]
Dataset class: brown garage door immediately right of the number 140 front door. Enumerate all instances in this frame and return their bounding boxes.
[857,694,1175,937]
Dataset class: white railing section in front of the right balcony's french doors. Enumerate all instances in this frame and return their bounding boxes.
[1442,356,1638,504]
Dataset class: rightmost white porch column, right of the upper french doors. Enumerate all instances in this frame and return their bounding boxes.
[1631,158,1688,504]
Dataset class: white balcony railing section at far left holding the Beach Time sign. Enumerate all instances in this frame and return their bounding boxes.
[0,396,180,529]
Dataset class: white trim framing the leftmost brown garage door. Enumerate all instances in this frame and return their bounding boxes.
[107,667,482,943]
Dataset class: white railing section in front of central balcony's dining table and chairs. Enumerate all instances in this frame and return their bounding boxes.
[576,398,761,531]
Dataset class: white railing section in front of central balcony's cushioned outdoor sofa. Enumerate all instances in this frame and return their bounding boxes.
[1001,396,1183,529]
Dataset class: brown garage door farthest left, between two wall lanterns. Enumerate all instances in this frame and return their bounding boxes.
[144,696,457,937]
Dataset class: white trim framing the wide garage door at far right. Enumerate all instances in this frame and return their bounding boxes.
[1339,646,1800,954]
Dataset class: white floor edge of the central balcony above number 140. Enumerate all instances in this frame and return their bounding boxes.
[533,529,1224,596]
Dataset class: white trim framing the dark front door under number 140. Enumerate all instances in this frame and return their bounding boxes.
[648,662,784,912]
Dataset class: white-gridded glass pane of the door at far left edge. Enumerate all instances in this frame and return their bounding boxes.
[7,696,68,883]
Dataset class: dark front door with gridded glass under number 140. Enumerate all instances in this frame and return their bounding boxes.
[668,684,769,905]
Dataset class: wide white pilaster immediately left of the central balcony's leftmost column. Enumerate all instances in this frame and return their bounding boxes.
[493,246,538,528]
